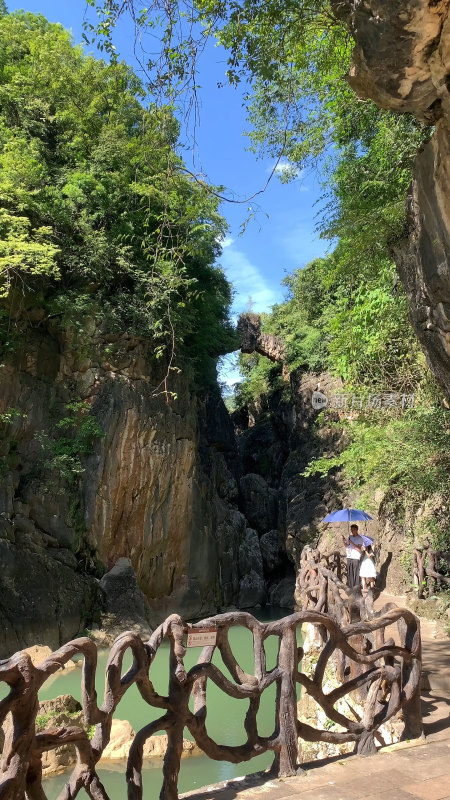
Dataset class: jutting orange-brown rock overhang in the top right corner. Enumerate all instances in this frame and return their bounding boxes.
[332,0,450,124]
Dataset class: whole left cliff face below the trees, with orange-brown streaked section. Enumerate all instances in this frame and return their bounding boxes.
[0,323,262,655]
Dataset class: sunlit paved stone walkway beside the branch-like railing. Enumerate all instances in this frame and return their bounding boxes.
[182,595,450,800]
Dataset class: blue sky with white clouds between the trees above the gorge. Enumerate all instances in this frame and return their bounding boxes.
[7,0,327,382]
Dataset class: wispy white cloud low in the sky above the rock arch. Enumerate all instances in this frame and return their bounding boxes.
[221,246,282,314]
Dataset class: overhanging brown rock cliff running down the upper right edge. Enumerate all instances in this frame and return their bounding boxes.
[332,0,450,397]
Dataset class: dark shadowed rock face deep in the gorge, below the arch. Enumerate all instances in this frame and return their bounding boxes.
[233,370,343,606]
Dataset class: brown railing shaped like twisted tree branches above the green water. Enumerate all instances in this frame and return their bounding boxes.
[0,592,421,800]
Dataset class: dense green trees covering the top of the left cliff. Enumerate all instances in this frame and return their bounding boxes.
[0,12,234,386]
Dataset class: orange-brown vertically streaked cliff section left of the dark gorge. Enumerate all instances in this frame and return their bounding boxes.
[82,360,245,621]
